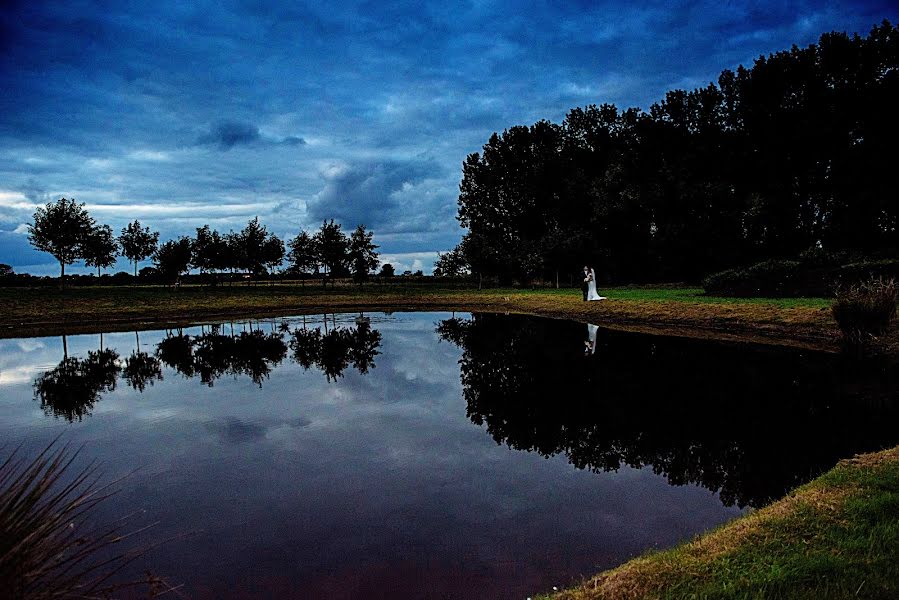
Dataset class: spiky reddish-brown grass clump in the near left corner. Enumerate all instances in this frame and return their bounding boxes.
[0,440,169,600]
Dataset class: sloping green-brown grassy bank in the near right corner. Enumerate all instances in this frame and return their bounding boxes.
[543,447,899,600]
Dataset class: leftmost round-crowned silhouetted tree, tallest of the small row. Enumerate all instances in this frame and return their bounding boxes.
[28,198,94,287]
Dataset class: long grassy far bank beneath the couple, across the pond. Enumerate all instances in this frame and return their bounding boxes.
[0,285,838,349]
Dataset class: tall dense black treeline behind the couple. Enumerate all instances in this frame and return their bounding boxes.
[448,21,899,282]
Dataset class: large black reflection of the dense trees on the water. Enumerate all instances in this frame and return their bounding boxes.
[436,314,899,506]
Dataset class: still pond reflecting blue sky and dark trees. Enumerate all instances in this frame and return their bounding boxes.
[0,313,899,598]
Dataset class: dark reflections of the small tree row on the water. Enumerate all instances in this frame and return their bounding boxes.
[32,317,381,422]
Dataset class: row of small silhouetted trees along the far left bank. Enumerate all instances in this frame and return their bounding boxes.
[28,198,384,282]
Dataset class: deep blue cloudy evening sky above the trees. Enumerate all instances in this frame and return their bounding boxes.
[0,0,899,274]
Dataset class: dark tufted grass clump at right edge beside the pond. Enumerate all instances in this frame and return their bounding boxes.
[831,277,899,350]
